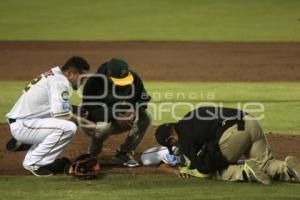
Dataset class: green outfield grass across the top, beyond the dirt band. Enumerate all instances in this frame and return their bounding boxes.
[0,0,300,41]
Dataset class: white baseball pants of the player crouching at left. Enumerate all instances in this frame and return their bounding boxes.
[10,118,77,170]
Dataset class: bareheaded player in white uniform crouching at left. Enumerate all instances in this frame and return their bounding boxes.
[6,57,95,176]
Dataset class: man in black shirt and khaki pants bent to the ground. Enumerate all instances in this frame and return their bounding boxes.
[155,107,300,185]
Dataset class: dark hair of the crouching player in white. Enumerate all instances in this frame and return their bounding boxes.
[61,56,90,74]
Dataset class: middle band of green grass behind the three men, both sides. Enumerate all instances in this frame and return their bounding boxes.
[0,81,300,134]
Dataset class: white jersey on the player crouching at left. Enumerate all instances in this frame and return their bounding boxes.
[6,67,72,119]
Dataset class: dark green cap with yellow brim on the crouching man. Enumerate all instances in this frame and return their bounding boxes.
[107,58,134,86]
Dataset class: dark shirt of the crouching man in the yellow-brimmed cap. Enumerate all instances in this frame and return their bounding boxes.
[83,63,151,122]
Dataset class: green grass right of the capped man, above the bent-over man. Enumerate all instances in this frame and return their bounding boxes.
[147,82,300,134]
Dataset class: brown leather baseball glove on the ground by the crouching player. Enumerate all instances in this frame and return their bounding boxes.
[65,154,100,180]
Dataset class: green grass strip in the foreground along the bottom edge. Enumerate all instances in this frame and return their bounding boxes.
[0,175,300,200]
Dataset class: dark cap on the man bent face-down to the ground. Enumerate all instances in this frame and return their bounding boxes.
[155,123,173,154]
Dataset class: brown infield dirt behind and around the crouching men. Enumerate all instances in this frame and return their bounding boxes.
[0,42,300,175]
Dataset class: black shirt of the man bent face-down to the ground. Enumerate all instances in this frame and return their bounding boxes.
[174,107,246,171]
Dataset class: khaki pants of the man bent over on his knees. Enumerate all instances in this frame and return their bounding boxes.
[216,115,290,181]
